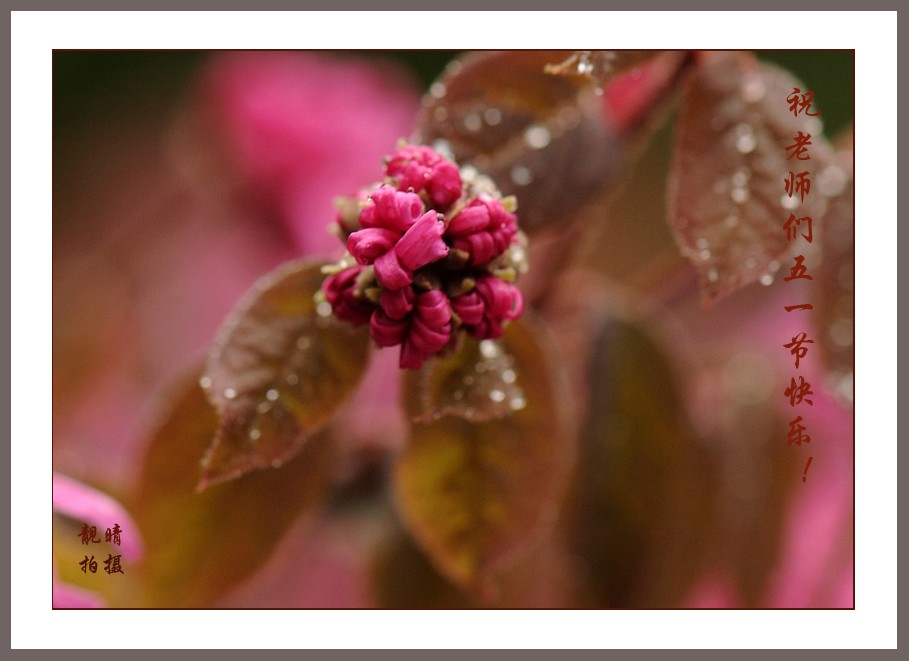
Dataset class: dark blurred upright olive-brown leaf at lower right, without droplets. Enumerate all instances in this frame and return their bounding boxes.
[567,317,713,608]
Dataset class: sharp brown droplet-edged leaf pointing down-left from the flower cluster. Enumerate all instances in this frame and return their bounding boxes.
[200,260,369,488]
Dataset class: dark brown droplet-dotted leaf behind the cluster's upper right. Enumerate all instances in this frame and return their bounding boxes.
[416,51,619,234]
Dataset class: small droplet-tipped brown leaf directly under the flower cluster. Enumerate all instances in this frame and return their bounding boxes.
[406,337,527,422]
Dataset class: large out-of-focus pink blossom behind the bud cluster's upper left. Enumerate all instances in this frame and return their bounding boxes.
[200,52,418,255]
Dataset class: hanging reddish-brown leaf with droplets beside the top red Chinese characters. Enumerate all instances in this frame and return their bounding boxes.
[668,52,830,302]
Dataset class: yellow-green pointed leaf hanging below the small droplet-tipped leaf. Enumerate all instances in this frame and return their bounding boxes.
[393,320,573,599]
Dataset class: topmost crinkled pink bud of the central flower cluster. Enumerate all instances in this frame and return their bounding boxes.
[385,145,462,209]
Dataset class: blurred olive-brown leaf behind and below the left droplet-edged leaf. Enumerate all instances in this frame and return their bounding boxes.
[131,368,333,608]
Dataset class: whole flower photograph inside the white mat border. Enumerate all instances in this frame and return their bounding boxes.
[53,50,855,609]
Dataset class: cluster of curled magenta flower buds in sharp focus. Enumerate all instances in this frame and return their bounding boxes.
[322,145,526,369]
